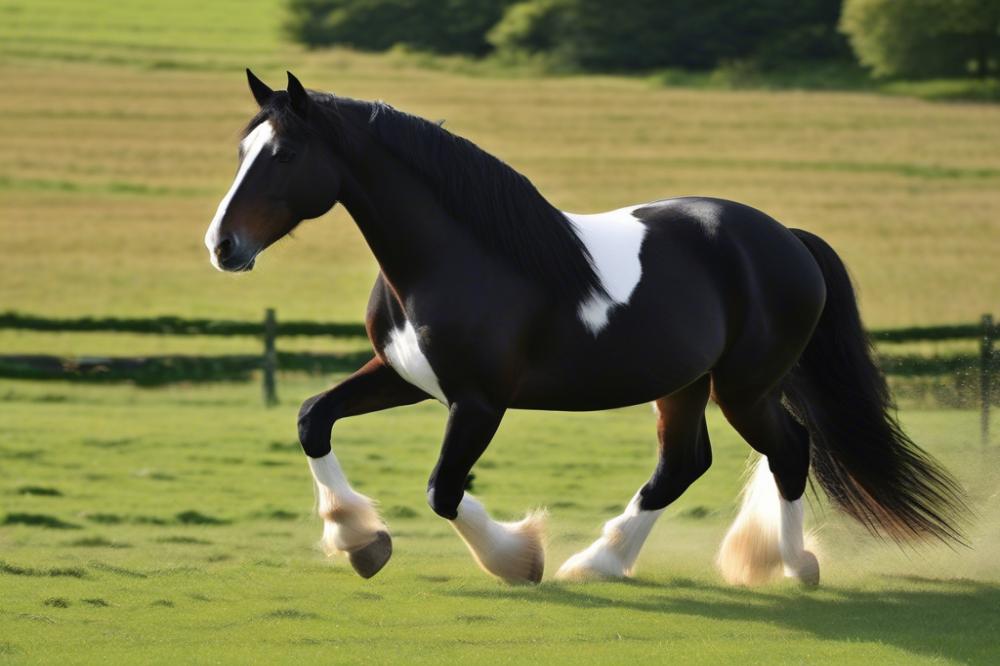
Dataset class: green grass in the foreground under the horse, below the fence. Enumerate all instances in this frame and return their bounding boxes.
[0,377,1000,664]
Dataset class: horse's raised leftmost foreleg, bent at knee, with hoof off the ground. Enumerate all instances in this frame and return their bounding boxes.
[299,358,428,578]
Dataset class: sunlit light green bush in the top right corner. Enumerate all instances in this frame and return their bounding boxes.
[841,0,1000,78]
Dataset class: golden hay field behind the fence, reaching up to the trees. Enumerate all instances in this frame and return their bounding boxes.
[0,0,1000,326]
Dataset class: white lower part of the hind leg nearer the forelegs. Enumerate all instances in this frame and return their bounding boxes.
[556,493,663,580]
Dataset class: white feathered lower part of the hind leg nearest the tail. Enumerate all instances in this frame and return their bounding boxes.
[716,456,819,585]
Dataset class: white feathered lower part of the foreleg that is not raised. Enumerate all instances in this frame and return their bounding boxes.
[451,493,547,583]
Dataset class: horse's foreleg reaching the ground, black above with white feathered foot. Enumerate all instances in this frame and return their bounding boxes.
[427,400,545,583]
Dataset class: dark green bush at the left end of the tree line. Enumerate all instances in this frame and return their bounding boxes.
[285,0,512,55]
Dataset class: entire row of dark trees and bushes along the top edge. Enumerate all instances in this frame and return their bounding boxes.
[285,0,1000,78]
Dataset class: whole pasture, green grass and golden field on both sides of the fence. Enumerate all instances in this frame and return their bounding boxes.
[0,0,1000,664]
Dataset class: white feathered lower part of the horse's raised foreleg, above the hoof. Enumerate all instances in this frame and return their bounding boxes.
[309,451,388,555]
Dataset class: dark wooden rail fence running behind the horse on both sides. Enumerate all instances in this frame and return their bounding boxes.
[0,309,1000,445]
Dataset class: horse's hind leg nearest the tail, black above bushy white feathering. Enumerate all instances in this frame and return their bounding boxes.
[717,393,819,585]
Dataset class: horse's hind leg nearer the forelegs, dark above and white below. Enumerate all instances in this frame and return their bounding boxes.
[556,375,712,580]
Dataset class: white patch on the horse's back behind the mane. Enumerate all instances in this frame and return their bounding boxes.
[564,206,646,336]
